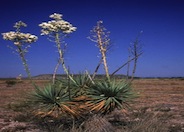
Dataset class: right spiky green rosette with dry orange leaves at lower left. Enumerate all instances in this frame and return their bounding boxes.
[86,80,135,114]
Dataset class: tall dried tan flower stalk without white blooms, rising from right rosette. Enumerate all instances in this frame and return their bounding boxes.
[89,21,110,81]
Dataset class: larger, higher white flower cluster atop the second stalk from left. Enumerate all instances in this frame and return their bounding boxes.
[39,13,77,35]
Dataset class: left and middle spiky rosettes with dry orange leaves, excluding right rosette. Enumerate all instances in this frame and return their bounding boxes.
[29,74,92,118]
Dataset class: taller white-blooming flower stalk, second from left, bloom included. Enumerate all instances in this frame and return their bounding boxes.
[39,13,77,84]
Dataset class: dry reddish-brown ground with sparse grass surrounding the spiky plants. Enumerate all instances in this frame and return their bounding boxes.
[0,79,184,132]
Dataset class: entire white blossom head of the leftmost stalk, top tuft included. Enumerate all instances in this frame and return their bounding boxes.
[2,21,38,45]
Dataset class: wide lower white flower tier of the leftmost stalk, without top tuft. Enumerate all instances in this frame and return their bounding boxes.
[2,31,38,45]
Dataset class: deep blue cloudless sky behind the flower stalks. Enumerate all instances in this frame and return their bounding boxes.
[0,0,184,77]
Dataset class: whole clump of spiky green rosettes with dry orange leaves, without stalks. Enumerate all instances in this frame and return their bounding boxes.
[27,74,135,118]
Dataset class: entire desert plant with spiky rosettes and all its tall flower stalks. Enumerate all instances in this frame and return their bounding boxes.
[2,13,142,132]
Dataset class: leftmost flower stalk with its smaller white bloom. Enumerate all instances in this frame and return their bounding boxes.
[2,21,38,79]
